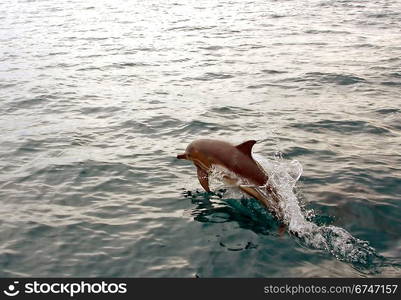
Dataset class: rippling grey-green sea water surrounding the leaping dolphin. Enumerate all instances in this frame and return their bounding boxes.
[0,0,401,277]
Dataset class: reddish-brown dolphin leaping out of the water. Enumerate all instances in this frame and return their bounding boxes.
[177,139,283,220]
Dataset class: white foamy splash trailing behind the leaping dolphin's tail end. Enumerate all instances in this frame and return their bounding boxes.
[213,155,378,266]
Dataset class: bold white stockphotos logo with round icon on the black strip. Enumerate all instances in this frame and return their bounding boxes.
[3,280,127,298]
